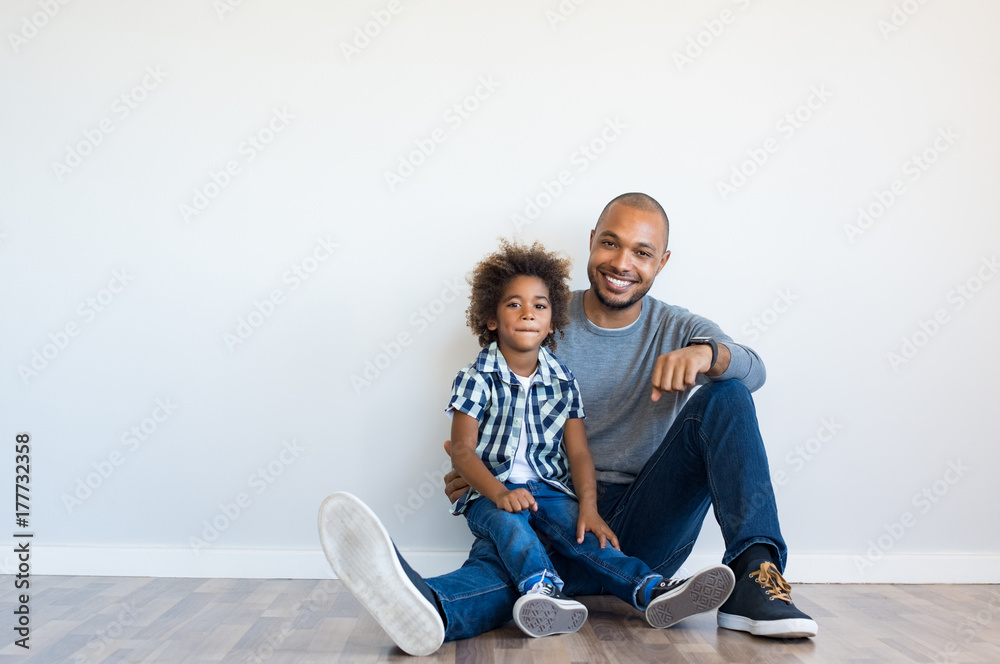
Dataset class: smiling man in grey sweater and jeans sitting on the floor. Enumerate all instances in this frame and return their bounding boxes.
[320,193,817,654]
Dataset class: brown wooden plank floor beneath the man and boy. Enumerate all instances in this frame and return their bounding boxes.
[0,576,1000,664]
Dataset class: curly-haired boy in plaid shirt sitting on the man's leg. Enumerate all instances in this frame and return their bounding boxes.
[447,242,732,637]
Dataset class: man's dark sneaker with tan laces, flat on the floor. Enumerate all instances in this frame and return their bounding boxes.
[719,560,817,639]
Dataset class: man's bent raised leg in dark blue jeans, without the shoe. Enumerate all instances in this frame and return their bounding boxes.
[605,380,787,576]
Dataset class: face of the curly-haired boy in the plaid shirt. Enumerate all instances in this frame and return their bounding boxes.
[486,275,553,353]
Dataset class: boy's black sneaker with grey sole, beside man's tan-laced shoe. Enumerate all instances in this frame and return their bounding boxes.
[646,565,735,629]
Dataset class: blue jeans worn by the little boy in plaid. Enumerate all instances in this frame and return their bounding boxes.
[465,481,660,609]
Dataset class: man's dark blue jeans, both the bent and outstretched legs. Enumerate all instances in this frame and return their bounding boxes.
[427,380,787,641]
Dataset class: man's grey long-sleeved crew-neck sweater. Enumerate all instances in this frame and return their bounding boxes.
[555,291,765,484]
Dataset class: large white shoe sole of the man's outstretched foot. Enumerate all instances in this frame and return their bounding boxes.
[319,493,444,656]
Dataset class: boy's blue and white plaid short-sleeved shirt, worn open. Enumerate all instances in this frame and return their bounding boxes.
[445,342,584,514]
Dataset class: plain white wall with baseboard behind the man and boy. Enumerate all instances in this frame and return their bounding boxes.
[0,0,1000,581]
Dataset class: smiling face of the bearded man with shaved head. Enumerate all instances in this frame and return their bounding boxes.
[587,203,670,309]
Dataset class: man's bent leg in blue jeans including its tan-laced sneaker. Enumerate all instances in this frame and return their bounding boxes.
[592,380,816,636]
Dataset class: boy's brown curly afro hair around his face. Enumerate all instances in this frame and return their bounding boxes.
[465,240,571,350]
